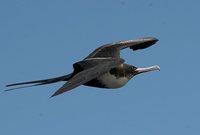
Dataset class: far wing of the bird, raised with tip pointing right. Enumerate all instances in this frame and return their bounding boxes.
[85,38,158,59]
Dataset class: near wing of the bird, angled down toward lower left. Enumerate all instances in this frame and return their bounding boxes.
[52,58,124,97]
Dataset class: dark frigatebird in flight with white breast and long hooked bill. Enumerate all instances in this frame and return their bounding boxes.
[5,38,160,97]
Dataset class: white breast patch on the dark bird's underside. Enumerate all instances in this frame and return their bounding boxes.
[97,72,128,88]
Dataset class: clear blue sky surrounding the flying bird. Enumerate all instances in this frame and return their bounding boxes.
[0,0,200,135]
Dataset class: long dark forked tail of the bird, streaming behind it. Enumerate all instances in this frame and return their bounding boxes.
[5,74,72,91]
